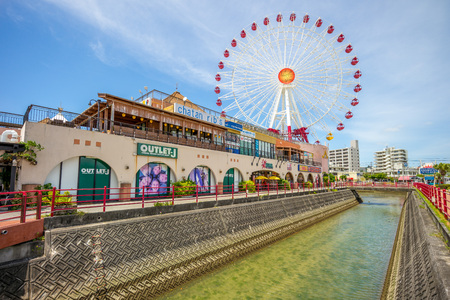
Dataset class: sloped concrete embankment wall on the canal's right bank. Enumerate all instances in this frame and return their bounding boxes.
[381,191,450,299]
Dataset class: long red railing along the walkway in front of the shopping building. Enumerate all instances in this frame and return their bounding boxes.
[0,182,411,223]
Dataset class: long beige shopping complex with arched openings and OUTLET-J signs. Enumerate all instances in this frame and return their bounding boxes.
[0,90,328,193]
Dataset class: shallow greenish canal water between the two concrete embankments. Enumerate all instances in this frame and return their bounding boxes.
[161,192,406,299]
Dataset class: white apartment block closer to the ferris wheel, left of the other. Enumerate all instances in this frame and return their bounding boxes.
[328,140,359,173]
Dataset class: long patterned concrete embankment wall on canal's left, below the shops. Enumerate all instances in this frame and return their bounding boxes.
[0,190,358,299]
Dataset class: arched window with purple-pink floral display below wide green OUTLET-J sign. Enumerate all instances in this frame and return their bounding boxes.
[136,162,175,196]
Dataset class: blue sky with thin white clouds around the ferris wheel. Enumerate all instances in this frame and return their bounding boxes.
[0,0,450,166]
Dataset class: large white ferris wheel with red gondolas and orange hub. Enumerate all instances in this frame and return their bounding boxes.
[214,13,362,143]
